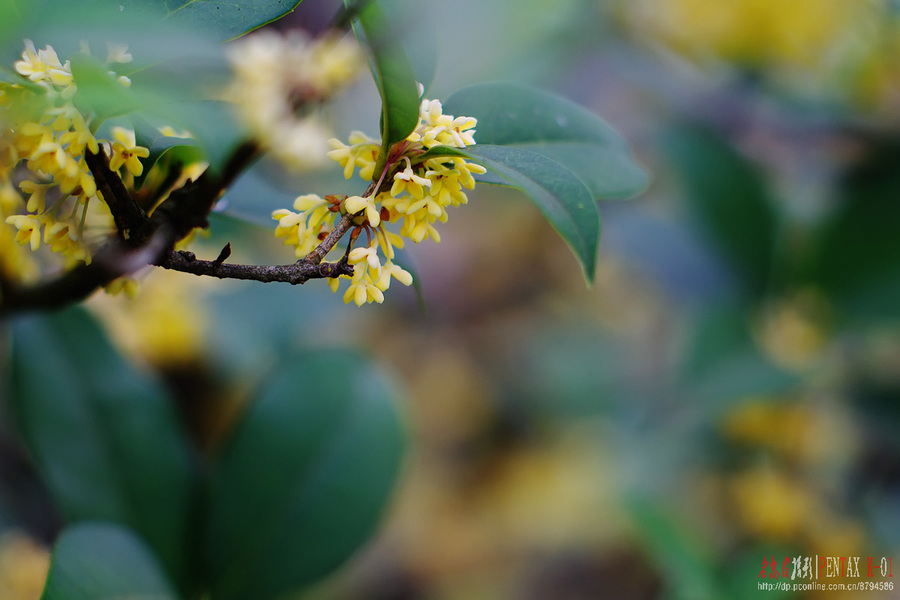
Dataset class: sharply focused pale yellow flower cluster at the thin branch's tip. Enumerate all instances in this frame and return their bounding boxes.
[272,100,485,306]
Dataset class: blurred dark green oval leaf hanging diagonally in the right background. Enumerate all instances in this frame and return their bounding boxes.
[663,125,778,296]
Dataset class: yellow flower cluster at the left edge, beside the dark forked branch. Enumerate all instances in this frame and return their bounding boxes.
[0,40,149,268]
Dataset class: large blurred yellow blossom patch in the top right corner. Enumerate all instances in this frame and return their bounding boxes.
[614,0,900,112]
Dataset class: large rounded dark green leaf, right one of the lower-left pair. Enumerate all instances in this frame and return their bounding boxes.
[206,351,403,600]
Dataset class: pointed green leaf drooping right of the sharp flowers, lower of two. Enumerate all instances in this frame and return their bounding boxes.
[465,144,600,283]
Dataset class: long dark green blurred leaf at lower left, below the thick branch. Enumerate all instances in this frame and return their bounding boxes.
[10,309,195,581]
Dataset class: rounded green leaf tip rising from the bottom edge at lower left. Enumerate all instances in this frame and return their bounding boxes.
[41,523,178,600]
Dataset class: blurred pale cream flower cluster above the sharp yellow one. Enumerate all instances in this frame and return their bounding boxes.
[226,30,365,169]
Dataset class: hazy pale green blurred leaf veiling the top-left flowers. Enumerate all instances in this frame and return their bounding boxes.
[0,0,245,168]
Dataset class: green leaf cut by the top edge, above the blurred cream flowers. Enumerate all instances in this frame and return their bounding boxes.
[163,0,302,40]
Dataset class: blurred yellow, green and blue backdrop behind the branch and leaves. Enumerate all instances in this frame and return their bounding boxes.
[0,0,900,600]
